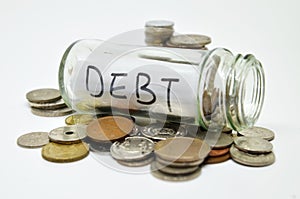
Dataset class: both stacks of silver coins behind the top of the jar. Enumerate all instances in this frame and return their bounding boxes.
[145,20,211,50]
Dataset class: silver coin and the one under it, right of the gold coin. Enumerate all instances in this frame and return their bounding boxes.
[110,136,154,167]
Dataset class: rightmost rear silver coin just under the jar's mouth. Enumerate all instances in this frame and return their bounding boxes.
[238,127,275,141]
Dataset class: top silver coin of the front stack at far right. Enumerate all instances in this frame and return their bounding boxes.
[234,137,273,153]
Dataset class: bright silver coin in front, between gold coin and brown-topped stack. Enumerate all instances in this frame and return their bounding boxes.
[110,137,154,161]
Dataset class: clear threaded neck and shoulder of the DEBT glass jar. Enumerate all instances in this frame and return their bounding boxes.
[200,48,265,130]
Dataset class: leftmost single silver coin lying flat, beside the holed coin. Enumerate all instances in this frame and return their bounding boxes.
[17,132,49,148]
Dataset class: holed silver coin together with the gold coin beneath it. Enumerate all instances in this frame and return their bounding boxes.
[42,125,89,162]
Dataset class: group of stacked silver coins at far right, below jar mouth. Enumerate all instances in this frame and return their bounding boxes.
[230,127,275,167]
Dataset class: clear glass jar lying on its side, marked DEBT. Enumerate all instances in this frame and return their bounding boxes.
[59,36,265,130]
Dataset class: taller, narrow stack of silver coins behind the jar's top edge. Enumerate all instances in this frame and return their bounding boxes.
[145,20,174,46]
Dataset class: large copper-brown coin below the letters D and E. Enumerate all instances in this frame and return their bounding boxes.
[87,116,134,142]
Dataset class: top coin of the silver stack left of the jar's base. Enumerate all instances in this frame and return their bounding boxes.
[26,88,61,103]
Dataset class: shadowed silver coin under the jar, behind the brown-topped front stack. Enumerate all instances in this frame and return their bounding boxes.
[141,123,187,140]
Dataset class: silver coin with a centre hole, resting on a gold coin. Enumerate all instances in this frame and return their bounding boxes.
[49,125,86,144]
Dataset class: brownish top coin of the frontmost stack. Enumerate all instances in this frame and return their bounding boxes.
[154,137,210,162]
